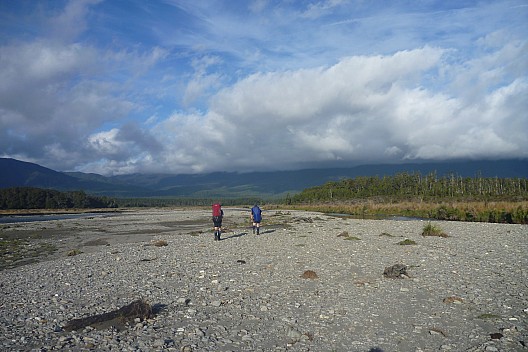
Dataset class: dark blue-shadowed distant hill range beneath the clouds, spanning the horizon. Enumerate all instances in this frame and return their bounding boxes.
[0,158,528,198]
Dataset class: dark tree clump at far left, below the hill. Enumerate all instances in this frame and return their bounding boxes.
[0,187,118,209]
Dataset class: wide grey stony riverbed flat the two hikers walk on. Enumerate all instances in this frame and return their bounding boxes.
[0,208,528,352]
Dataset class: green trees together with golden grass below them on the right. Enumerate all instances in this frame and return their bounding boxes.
[285,173,528,224]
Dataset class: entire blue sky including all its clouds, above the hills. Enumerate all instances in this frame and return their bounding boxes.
[0,0,528,175]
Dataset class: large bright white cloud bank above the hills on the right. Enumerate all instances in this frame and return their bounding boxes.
[141,47,528,172]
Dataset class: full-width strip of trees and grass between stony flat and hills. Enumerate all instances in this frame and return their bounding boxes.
[0,173,528,224]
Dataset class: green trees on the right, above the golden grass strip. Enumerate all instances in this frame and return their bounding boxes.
[287,172,528,204]
